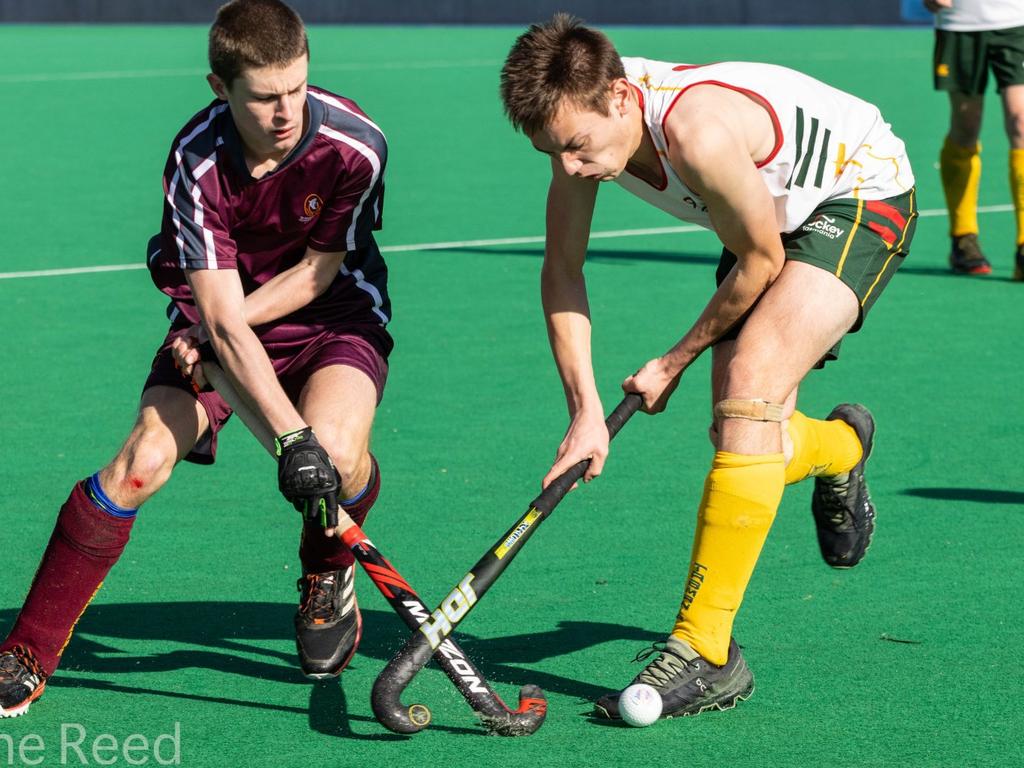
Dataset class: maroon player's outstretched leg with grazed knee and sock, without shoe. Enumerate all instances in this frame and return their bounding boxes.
[0,386,209,675]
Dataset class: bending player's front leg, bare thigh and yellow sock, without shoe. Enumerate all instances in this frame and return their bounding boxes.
[673,261,858,665]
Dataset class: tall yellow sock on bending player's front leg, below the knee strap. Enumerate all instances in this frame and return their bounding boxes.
[672,451,784,665]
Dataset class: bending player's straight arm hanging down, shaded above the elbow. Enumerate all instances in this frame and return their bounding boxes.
[538,154,608,487]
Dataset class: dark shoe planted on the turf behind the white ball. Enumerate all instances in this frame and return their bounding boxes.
[594,635,754,720]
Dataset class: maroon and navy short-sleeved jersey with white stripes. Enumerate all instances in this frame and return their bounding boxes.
[150,87,391,335]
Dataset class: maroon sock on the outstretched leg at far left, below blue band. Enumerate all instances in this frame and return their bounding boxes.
[0,483,135,675]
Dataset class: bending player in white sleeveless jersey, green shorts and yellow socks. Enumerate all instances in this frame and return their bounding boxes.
[502,14,916,719]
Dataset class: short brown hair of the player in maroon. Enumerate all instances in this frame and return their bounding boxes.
[210,0,309,87]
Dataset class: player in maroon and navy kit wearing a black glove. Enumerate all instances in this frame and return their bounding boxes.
[0,0,391,717]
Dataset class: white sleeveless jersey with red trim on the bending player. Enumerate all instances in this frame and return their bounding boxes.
[615,57,913,232]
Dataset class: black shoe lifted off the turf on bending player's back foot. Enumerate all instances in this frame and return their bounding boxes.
[811,403,874,568]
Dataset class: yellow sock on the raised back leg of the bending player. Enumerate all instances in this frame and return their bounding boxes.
[785,411,864,485]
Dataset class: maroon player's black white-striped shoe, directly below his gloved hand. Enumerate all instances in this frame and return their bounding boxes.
[295,565,362,680]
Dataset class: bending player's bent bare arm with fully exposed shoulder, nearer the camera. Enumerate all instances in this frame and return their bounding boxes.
[623,86,785,413]
